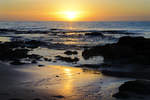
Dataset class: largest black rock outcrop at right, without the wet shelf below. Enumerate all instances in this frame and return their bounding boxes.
[82,36,150,64]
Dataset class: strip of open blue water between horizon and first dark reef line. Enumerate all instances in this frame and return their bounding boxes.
[0,21,150,32]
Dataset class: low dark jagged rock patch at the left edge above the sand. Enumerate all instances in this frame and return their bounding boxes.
[0,40,43,65]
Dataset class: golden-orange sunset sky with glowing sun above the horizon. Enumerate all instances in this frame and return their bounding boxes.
[0,0,150,21]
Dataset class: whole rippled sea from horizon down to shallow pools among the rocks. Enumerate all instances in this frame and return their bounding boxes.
[0,21,150,65]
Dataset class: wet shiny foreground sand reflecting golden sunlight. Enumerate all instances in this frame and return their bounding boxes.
[0,64,129,100]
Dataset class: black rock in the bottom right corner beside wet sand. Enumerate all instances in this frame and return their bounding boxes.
[113,80,150,98]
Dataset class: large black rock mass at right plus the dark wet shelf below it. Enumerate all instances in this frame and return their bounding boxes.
[82,36,150,79]
